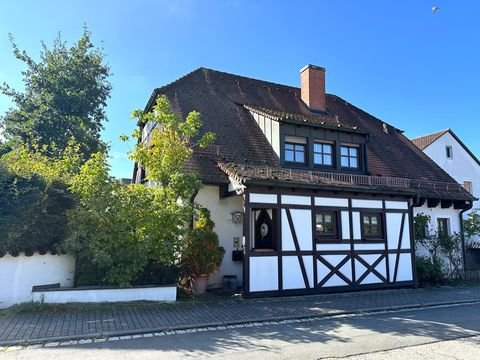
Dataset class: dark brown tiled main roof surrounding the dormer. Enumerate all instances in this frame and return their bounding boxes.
[145,68,472,200]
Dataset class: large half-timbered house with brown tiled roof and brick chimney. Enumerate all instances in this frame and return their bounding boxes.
[135,65,473,297]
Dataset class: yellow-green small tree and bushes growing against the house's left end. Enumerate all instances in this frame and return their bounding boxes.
[66,97,214,286]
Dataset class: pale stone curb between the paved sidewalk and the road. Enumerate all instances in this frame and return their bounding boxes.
[0,300,480,352]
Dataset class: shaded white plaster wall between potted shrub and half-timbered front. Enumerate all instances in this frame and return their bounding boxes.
[195,185,243,287]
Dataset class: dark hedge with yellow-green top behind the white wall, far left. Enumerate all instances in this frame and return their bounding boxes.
[0,143,81,254]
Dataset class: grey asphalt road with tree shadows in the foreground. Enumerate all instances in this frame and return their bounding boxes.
[0,304,480,360]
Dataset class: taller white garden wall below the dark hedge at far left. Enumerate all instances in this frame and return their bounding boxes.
[0,253,75,309]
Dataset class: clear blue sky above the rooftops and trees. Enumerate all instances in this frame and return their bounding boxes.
[0,0,480,177]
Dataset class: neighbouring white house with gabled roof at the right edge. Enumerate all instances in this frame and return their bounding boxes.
[412,129,480,210]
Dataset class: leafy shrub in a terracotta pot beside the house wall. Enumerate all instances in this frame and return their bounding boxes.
[182,208,225,295]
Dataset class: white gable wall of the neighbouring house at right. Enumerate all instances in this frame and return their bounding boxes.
[423,132,480,209]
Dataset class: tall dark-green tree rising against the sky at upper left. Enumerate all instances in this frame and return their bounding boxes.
[0,27,111,160]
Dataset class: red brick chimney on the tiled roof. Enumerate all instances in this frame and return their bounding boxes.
[300,65,327,111]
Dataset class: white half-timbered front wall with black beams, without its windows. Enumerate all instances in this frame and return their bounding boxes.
[246,191,414,295]
